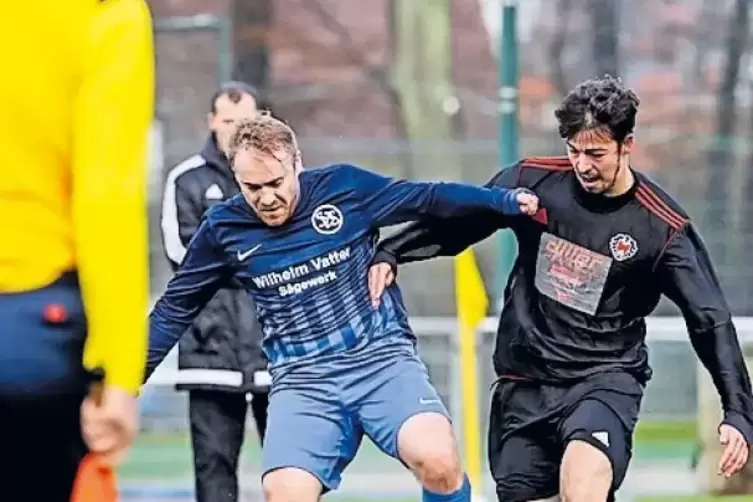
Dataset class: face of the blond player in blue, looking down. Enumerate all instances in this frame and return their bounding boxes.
[233,149,300,227]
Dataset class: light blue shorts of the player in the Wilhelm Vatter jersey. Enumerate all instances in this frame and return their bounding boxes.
[263,340,449,491]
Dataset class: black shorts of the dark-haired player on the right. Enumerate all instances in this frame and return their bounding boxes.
[488,373,643,502]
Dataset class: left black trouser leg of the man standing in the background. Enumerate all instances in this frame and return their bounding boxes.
[188,390,247,502]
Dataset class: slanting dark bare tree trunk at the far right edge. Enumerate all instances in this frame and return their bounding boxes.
[706,0,750,260]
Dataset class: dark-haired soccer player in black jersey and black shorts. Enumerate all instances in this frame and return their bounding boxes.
[369,76,753,502]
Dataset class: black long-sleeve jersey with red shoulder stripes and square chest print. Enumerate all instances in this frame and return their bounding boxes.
[381,157,753,442]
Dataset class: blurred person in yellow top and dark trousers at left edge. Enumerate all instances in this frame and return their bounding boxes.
[0,0,154,502]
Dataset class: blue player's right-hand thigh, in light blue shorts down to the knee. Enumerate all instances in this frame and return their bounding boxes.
[357,351,456,467]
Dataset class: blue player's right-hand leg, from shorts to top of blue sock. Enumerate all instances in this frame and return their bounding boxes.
[357,348,471,501]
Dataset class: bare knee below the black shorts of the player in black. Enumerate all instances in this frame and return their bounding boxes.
[560,440,612,502]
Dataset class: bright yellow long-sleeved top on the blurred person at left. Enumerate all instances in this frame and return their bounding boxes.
[0,0,154,391]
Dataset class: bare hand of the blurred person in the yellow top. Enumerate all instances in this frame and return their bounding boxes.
[81,386,138,467]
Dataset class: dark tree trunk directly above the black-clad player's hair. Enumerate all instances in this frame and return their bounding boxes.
[589,0,620,76]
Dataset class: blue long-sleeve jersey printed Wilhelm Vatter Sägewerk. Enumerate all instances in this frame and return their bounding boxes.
[147,164,519,376]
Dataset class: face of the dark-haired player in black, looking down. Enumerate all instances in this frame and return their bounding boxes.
[567,130,633,195]
